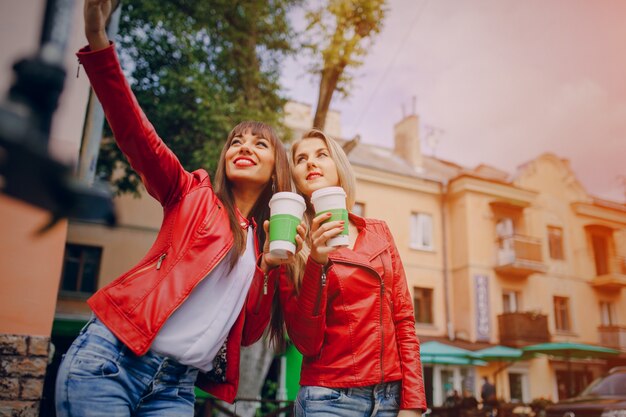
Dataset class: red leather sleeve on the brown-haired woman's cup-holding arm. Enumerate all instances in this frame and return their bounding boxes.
[241,266,284,346]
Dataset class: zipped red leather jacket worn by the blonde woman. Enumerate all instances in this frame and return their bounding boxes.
[279,214,426,410]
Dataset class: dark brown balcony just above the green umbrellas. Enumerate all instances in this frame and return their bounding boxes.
[498,312,550,347]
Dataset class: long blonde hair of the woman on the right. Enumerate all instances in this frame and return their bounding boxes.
[270,129,356,350]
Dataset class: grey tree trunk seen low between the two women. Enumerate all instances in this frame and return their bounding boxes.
[218,338,274,417]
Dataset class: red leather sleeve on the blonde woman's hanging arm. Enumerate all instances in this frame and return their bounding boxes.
[385,224,427,411]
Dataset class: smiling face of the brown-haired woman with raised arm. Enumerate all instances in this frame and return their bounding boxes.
[224,131,275,188]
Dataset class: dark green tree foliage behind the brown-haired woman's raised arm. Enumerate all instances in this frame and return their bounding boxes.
[98,0,300,193]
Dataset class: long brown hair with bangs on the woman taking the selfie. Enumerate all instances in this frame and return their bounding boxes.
[214,121,291,267]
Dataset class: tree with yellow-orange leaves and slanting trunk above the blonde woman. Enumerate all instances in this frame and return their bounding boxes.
[305,0,387,129]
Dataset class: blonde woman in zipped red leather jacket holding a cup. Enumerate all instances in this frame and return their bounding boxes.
[273,130,426,417]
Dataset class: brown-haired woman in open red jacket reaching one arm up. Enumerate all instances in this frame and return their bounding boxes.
[56,0,303,417]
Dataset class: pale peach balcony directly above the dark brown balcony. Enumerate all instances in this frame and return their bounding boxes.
[495,235,548,277]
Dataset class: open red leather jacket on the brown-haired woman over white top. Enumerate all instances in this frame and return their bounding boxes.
[77,46,277,402]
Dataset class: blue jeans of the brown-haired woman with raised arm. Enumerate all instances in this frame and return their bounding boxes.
[55,318,198,417]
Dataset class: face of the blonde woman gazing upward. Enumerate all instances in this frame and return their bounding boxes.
[291,138,339,197]
